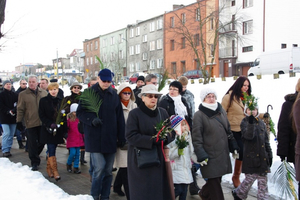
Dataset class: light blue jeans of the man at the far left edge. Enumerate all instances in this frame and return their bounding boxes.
[2,124,17,153]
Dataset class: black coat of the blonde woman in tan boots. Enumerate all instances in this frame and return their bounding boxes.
[39,94,68,144]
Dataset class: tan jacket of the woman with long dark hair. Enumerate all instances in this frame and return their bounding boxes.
[221,91,245,132]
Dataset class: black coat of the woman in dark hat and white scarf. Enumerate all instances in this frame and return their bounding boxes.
[158,94,193,130]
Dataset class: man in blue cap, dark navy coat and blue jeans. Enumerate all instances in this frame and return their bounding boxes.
[77,69,125,200]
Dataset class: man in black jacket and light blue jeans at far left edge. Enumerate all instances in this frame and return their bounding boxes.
[0,80,18,157]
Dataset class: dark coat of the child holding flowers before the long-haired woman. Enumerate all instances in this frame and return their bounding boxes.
[241,117,273,175]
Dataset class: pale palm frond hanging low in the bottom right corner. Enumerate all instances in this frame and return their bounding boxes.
[271,160,298,200]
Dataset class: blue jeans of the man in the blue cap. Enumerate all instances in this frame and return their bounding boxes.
[90,153,115,199]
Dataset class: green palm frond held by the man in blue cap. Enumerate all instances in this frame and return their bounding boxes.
[78,88,102,118]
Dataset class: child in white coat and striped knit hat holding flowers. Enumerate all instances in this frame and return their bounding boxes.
[168,115,199,200]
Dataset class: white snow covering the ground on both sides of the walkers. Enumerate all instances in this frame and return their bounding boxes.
[0,74,300,200]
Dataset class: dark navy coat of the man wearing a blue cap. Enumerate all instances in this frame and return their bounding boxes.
[76,83,126,153]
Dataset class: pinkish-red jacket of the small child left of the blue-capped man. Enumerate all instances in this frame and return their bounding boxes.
[67,118,84,148]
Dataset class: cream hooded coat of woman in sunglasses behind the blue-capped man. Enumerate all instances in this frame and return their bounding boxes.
[114,84,137,168]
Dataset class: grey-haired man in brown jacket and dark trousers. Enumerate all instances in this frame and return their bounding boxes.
[17,75,47,171]
